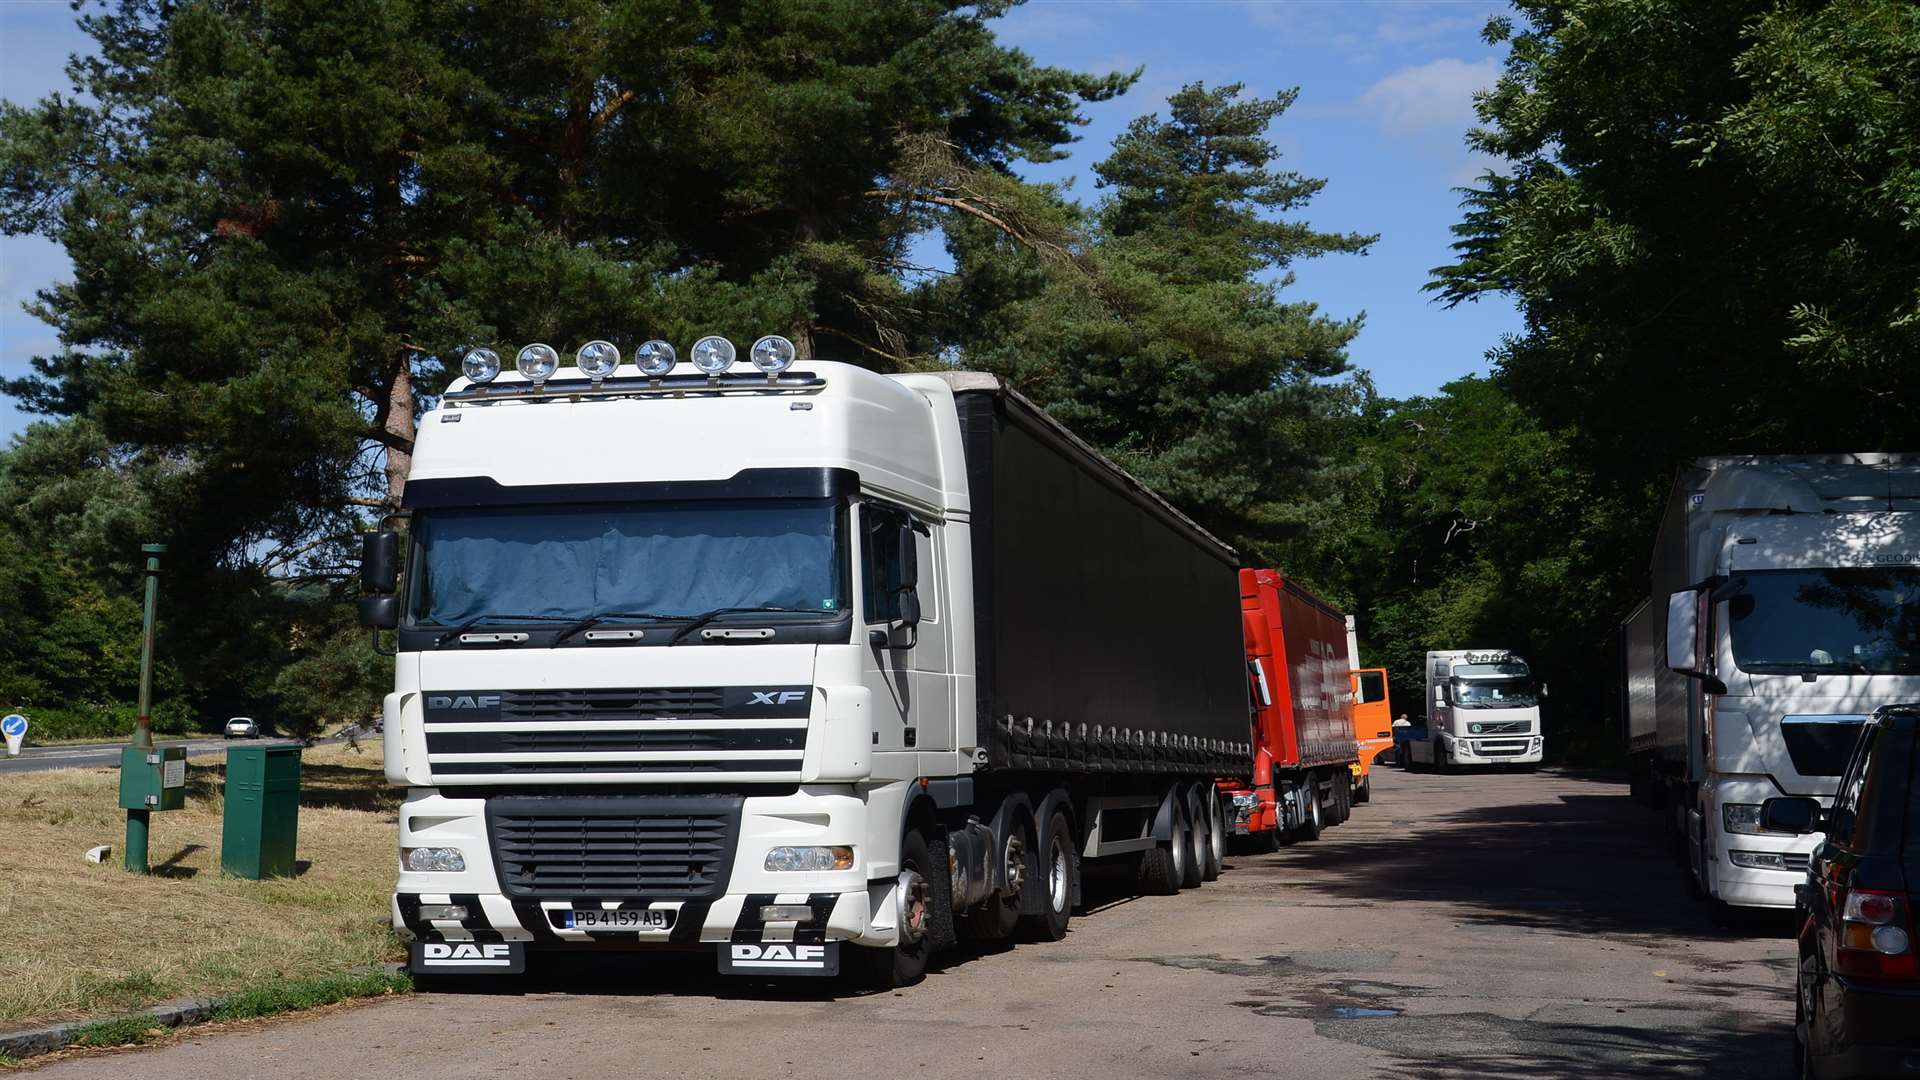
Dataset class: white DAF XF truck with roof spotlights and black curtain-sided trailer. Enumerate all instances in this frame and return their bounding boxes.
[361,336,1252,986]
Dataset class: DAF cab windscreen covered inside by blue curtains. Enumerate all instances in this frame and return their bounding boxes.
[409,500,847,626]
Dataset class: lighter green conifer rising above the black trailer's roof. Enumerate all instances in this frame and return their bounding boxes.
[924,83,1373,555]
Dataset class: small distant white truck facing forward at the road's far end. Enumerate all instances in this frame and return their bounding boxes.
[1405,650,1548,771]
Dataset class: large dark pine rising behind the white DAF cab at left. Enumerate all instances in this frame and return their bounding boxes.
[0,0,1133,723]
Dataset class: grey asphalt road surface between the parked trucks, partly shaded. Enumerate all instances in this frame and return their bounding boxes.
[35,771,1793,1080]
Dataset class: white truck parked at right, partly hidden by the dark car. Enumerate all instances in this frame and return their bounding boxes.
[1622,454,1920,911]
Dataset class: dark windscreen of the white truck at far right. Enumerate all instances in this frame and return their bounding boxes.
[1722,567,1920,675]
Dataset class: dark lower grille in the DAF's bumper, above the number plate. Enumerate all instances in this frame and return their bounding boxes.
[486,796,741,899]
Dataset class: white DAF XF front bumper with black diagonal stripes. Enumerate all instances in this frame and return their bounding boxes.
[392,786,899,949]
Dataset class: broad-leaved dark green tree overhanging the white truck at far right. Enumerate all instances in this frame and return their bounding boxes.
[1434,0,1920,472]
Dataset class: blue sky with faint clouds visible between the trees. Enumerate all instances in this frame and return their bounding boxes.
[0,0,1519,438]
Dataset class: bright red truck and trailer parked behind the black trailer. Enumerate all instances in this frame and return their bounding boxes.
[1219,571,1359,849]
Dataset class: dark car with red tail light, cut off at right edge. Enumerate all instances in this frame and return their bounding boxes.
[1761,705,1920,1080]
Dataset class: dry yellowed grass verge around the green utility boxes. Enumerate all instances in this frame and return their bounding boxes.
[0,740,403,1028]
